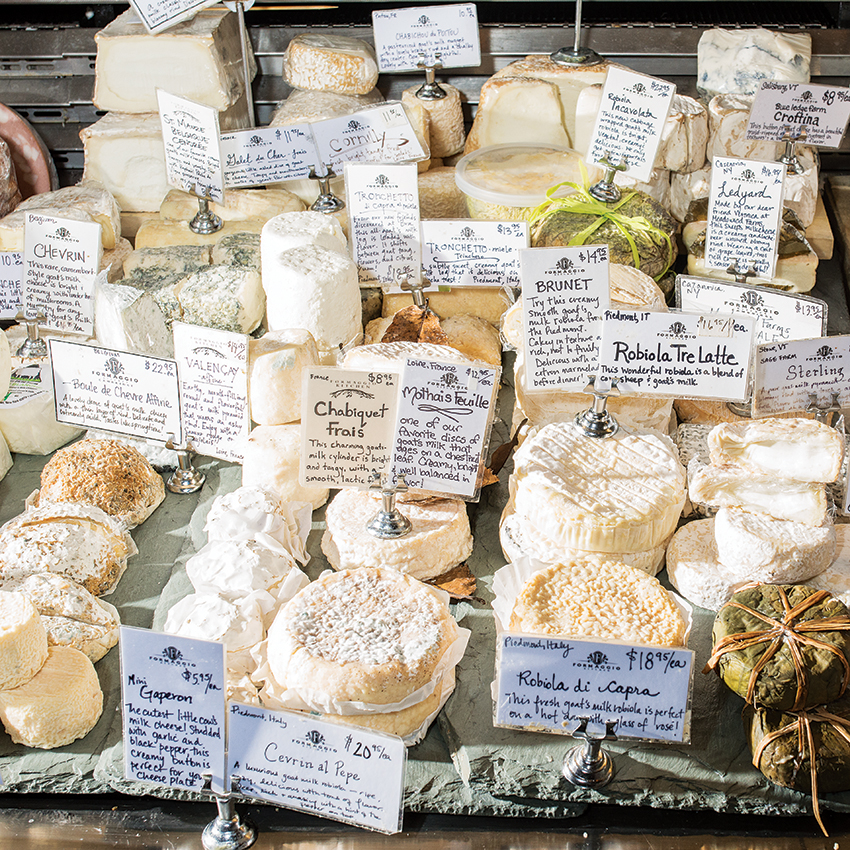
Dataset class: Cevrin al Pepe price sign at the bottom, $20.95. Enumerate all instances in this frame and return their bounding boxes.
[227,703,407,834]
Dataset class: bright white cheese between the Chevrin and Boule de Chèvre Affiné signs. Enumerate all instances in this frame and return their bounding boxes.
[94,282,174,358]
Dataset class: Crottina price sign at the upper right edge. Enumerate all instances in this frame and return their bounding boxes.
[747,80,850,148]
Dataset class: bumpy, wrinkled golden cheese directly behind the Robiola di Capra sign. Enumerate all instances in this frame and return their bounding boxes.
[510,561,685,646]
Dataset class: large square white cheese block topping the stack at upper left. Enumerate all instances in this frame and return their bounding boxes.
[92,7,256,112]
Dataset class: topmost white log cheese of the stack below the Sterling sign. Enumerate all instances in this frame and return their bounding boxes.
[708,419,844,483]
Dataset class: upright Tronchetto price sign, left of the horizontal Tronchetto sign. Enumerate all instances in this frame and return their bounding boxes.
[345,162,422,292]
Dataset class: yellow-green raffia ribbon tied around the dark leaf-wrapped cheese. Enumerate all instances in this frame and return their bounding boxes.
[531,163,673,282]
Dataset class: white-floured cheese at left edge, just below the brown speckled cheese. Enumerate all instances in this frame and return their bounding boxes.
[0,502,138,596]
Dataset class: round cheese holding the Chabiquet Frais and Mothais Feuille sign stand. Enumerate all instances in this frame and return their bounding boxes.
[322,488,472,579]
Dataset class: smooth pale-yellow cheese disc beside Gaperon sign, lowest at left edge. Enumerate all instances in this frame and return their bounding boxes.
[0,646,103,750]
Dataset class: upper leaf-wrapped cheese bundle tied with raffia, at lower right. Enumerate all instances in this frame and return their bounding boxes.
[705,584,850,711]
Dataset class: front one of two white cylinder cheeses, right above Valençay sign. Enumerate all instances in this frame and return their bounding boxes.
[261,245,363,365]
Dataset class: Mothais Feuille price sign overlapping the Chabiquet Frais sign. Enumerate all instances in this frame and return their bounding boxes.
[392,358,500,500]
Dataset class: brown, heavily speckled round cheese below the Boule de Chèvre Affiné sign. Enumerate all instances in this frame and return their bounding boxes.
[38,440,165,528]
